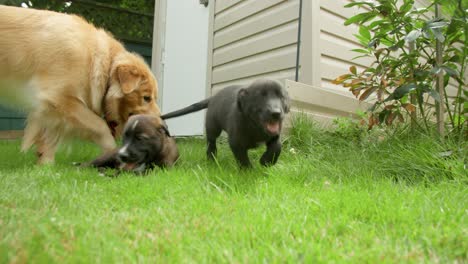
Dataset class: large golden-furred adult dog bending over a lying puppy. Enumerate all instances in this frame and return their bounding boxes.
[0,5,160,163]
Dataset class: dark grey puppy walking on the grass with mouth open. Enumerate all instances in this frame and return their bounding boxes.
[161,79,289,167]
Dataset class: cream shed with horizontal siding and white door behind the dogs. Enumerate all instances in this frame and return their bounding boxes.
[0,0,455,136]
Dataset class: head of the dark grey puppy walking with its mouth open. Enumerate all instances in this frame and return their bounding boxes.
[237,79,289,136]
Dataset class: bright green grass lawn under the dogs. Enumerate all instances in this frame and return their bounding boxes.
[0,118,468,263]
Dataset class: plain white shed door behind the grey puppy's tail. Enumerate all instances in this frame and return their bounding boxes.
[157,0,208,136]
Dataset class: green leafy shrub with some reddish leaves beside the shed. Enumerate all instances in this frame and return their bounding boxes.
[334,0,468,136]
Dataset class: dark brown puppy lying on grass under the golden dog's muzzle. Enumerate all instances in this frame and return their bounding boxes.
[86,115,179,173]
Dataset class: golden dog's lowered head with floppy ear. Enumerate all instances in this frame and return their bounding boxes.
[104,52,161,136]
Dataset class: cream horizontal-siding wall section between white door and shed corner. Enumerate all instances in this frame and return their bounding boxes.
[208,0,299,93]
